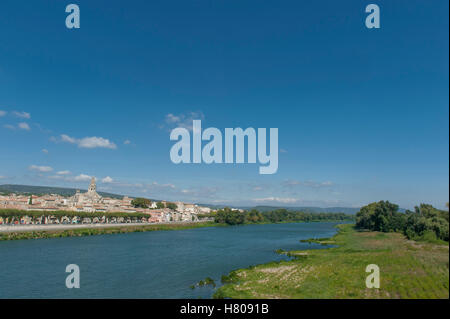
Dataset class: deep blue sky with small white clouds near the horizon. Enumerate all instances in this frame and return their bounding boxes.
[0,0,449,208]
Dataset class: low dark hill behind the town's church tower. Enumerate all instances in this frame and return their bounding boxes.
[0,184,126,199]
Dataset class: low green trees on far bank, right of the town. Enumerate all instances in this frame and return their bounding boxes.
[210,208,355,225]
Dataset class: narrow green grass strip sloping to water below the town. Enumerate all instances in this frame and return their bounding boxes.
[0,222,222,241]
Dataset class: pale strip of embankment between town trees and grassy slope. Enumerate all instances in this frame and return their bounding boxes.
[0,222,204,233]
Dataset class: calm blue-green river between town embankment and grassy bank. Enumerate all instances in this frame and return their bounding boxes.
[0,223,336,298]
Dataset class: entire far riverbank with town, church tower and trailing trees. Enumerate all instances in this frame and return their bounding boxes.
[0,178,353,239]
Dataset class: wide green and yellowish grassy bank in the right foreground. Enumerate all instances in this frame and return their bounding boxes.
[214,225,449,298]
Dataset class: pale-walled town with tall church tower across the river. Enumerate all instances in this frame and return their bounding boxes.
[0,177,218,225]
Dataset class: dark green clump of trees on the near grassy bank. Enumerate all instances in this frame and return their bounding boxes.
[356,201,449,241]
